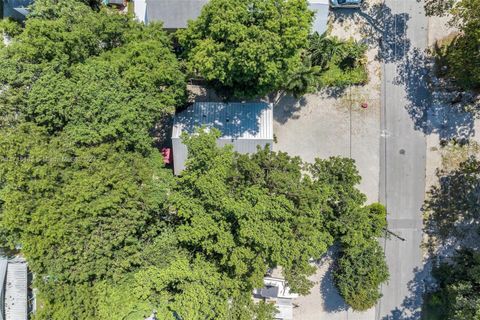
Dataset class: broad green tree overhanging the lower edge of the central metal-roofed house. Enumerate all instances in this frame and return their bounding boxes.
[172,129,332,292]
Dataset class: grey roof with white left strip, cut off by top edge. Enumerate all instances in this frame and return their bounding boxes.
[134,0,208,31]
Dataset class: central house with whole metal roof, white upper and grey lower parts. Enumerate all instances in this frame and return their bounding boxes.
[172,102,273,174]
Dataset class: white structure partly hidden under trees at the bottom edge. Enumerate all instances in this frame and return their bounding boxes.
[253,276,298,320]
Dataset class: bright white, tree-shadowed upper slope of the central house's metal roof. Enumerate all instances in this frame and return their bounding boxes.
[172,102,273,140]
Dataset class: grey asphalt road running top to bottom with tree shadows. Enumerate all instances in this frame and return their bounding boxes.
[376,0,428,320]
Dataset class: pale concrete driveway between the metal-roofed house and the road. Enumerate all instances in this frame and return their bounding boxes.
[273,67,381,202]
